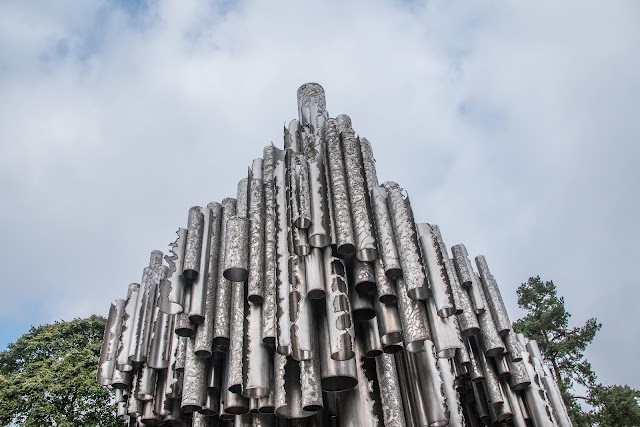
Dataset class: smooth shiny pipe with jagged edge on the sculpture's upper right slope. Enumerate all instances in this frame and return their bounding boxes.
[416,223,456,317]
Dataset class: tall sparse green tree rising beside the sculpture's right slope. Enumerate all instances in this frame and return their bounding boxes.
[513,276,602,426]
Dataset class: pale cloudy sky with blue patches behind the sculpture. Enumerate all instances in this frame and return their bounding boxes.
[0,0,640,388]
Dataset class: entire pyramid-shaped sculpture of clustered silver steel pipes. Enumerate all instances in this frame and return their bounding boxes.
[98,83,571,427]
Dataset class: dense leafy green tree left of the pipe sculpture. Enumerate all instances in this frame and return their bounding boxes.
[0,316,123,427]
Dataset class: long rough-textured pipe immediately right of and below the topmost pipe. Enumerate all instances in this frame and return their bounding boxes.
[325,119,356,256]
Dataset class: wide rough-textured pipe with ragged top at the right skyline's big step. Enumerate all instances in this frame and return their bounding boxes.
[383,182,428,300]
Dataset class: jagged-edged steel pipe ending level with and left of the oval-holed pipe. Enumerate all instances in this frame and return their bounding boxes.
[289,256,313,360]
